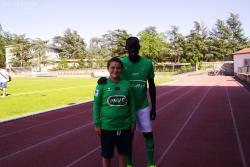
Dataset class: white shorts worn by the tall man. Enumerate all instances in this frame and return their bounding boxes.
[136,106,152,133]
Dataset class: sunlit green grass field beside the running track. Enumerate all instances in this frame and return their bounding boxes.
[0,77,173,121]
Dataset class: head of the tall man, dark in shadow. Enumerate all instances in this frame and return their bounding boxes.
[126,37,140,62]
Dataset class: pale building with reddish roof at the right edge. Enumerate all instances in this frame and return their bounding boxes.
[233,48,250,74]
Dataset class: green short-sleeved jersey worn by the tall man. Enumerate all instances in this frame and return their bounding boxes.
[121,56,154,110]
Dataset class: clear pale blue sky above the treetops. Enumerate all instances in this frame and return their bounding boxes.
[0,0,250,43]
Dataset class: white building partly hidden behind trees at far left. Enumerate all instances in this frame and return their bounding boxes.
[5,45,60,71]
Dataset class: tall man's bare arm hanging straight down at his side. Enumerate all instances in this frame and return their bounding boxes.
[148,78,156,120]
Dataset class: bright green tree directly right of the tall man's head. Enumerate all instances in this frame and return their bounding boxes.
[138,26,167,62]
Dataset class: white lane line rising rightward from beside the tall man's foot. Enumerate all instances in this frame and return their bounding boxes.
[157,86,211,165]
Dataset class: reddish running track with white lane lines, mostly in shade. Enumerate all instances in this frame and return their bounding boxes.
[0,76,250,167]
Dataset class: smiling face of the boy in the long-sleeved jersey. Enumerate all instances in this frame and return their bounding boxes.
[108,61,122,81]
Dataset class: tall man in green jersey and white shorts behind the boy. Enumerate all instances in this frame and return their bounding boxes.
[98,37,156,167]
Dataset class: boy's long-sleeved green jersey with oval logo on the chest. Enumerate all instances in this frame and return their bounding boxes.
[93,79,135,130]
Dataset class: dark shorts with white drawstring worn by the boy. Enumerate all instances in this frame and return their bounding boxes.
[101,129,132,159]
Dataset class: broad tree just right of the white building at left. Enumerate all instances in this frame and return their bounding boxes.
[53,29,86,59]
